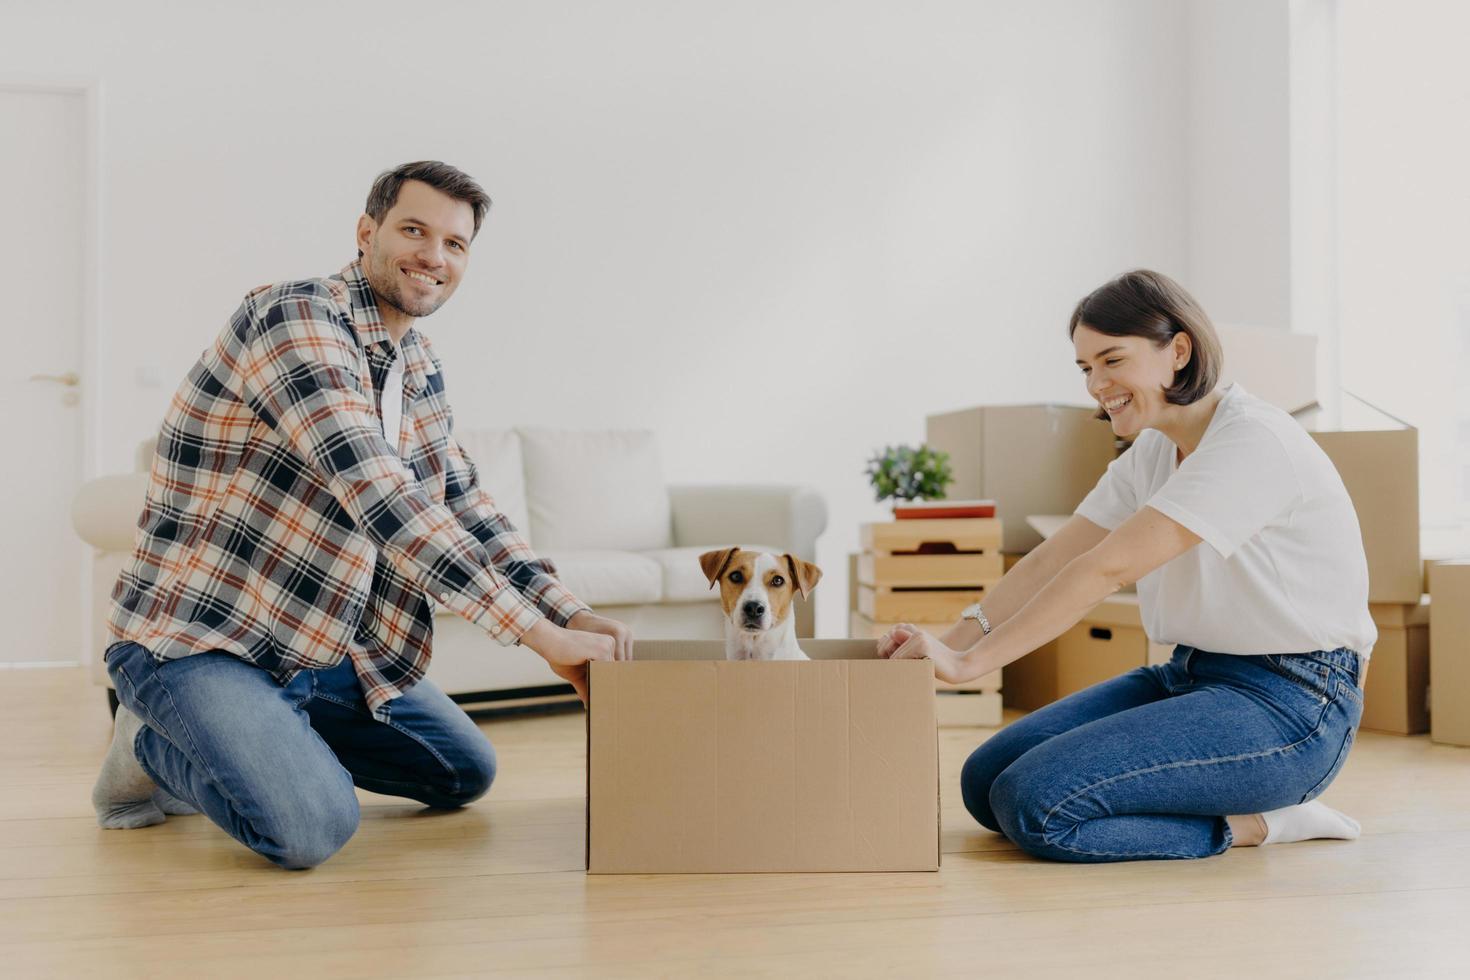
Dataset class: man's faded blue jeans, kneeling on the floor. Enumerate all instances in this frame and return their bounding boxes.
[106,644,495,868]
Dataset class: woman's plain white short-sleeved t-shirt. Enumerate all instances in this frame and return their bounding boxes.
[1078,385,1377,657]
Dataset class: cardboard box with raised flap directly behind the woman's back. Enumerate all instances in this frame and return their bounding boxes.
[1311,428,1424,605]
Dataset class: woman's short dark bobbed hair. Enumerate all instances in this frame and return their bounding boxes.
[1067,269,1225,419]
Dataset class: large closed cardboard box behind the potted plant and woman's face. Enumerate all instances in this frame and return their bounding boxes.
[925,406,1114,552]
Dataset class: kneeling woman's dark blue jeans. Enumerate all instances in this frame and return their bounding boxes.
[960,646,1363,861]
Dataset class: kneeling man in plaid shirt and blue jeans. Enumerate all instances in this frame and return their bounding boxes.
[93,162,632,868]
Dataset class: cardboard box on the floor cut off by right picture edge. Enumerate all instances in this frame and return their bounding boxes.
[1422,561,1470,745]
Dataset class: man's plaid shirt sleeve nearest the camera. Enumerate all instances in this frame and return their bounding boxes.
[238,295,541,645]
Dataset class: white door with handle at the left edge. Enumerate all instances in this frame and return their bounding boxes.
[0,85,87,664]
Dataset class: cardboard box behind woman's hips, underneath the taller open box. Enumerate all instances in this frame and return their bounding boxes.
[1361,597,1430,735]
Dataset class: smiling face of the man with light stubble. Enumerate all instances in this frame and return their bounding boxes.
[357,181,475,320]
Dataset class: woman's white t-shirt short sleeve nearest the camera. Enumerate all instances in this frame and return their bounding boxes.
[1147,422,1301,558]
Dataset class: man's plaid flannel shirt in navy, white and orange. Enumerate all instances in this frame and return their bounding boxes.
[109,262,587,717]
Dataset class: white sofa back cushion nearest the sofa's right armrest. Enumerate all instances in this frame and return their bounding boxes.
[519,429,673,551]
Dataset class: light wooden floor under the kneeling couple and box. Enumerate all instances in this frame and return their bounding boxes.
[0,670,1470,977]
